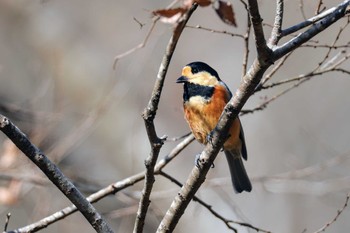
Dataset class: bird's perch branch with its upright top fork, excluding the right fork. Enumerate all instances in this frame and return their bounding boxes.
[157,0,271,232]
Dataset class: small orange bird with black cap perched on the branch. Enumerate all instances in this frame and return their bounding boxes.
[176,61,252,193]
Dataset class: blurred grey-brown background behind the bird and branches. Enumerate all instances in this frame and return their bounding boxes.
[0,0,350,232]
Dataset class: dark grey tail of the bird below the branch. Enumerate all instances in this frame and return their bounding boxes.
[225,150,252,193]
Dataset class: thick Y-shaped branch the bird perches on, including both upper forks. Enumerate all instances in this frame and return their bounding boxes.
[157,0,350,233]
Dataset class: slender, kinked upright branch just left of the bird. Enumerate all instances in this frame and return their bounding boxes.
[134,4,197,233]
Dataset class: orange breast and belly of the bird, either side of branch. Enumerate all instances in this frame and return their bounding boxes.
[184,86,241,150]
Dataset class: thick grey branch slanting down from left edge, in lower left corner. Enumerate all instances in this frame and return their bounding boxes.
[0,115,113,233]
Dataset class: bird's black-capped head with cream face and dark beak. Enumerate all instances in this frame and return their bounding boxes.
[176,61,220,86]
